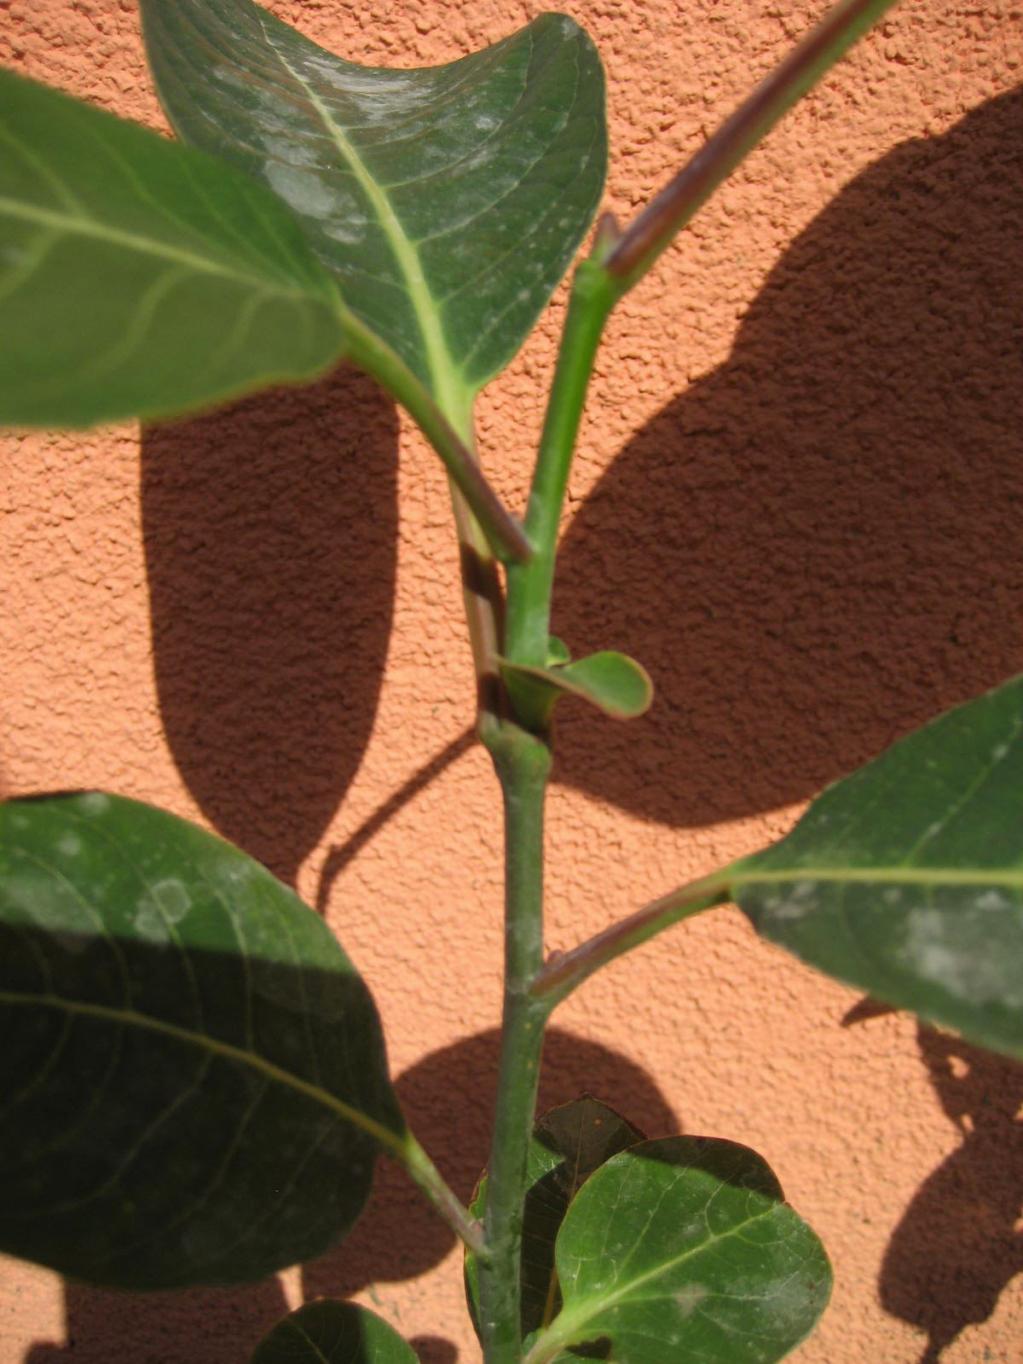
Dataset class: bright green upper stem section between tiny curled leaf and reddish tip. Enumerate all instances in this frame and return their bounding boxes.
[505,259,618,676]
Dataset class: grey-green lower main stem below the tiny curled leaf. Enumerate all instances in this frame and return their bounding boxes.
[479,722,551,1364]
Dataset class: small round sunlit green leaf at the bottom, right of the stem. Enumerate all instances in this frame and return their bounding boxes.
[527,1136,831,1364]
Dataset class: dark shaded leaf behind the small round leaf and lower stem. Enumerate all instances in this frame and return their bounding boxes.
[465,1094,642,1335]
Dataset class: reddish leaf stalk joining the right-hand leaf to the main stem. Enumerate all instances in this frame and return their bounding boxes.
[532,868,732,1008]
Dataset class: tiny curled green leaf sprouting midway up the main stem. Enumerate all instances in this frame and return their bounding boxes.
[501,641,653,722]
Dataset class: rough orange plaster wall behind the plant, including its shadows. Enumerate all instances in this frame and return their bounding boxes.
[0,0,1023,1364]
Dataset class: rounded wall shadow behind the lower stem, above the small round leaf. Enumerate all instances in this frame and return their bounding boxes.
[303,1027,679,1299]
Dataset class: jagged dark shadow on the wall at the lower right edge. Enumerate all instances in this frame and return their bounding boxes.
[878,1024,1023,1364]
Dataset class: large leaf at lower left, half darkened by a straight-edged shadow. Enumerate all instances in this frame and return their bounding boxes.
[0,792,406,1289]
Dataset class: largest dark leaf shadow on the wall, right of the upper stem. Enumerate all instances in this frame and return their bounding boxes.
[554,91,1023,827]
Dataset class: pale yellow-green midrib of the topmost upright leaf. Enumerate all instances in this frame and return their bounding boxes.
[258,15,465,420]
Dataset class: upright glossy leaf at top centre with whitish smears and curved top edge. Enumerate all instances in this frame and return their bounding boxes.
[140,0,607,423]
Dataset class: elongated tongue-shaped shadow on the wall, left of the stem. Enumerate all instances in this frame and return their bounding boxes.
[142,368,398,884]
